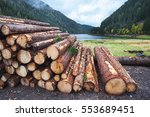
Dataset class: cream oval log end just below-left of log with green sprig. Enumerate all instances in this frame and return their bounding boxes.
[41,67,52,81]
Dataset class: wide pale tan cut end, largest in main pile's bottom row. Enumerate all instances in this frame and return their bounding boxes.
[57,81,72,93]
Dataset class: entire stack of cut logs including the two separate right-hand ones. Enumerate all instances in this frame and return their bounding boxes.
[0,16,137,95]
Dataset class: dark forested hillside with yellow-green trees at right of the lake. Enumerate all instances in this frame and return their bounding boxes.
[93,0,150,34]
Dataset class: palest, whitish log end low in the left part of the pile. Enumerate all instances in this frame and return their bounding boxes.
[16,65,28,77]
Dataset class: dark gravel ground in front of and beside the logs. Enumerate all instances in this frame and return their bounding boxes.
[0,66,150,100]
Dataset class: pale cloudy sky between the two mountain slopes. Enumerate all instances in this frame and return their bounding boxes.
[42,0,127,26]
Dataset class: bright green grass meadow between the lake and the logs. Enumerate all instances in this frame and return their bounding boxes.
[81,39,150,56]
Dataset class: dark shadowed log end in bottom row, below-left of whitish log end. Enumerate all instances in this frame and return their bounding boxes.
[7,75,20,87]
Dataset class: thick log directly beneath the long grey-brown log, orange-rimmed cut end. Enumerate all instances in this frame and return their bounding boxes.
[16,31,69,48]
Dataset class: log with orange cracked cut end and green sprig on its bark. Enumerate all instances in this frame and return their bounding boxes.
[50,42,78,74]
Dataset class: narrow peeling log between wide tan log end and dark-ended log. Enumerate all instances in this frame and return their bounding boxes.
[73,48,87,92]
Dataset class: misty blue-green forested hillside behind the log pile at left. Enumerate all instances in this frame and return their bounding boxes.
[0,0,92,33]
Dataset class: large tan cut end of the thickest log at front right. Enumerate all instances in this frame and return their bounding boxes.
[105,78,126,95]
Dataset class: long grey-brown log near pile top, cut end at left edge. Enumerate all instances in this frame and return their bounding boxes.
[1,24,59,35]
